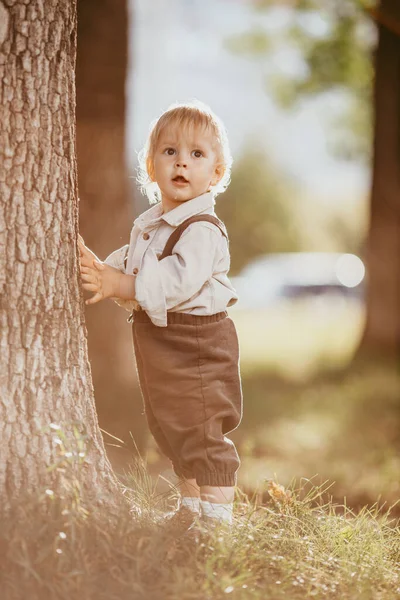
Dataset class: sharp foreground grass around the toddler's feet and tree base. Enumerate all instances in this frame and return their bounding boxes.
[0,460,400,600]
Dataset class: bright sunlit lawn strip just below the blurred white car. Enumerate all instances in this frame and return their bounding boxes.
[229,298,365,381]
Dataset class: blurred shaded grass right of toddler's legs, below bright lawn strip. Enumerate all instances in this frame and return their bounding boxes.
[232,364,400,509]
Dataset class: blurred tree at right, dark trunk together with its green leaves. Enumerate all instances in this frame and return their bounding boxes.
[230,0,400,356]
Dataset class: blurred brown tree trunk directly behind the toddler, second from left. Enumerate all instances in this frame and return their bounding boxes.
[77,0,146,460]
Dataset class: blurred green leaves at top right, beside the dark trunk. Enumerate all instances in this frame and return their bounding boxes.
[228,0,376,159]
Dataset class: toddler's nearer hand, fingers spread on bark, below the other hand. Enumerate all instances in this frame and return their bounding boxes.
[81,259,123,304]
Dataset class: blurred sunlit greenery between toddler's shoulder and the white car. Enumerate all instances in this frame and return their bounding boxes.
[217,145,366,275]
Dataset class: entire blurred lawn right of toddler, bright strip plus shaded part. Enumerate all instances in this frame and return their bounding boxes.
[223,300,400,510]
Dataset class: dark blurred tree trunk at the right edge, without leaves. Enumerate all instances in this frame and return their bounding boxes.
[360,0,400,357]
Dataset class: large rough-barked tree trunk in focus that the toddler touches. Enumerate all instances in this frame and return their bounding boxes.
[0,0,115,508]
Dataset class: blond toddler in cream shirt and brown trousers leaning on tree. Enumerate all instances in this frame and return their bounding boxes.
[79,101,242,523]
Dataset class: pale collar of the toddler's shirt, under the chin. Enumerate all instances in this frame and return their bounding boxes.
[134,192,215,229]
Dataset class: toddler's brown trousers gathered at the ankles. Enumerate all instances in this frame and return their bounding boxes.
[132,311,243,486]
